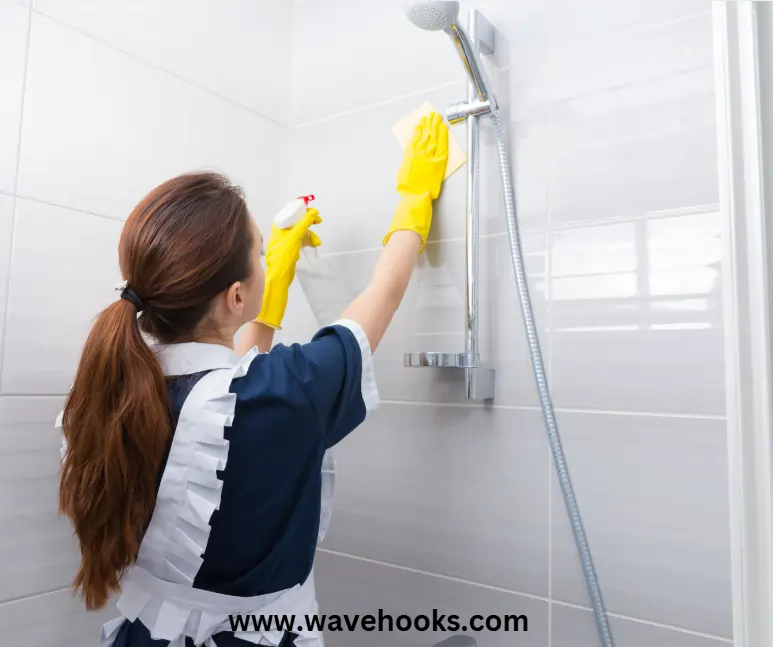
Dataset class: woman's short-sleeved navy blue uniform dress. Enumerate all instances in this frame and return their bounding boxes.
[115,326,366,647]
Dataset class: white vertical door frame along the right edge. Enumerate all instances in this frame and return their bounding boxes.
[713,0,773,647]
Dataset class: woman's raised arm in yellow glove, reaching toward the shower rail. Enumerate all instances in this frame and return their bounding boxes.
[341,113,448,351]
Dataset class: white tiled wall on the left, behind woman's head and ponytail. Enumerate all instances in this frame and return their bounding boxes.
[0,0,292,647]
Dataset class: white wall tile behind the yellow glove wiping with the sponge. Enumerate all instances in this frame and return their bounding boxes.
[289,101,547,253]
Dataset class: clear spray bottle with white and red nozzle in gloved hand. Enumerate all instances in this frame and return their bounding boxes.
[274,195,356,328]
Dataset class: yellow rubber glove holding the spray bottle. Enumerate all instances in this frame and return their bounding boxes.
[255,209,322,329]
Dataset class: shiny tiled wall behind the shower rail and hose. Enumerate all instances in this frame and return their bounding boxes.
[286,0,731,647]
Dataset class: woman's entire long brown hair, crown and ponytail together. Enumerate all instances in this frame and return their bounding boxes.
[59,173,254,609]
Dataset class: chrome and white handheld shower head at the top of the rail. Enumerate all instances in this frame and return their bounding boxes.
[405,0,497,111]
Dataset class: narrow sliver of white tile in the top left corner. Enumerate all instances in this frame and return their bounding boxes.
[0,0,29,193]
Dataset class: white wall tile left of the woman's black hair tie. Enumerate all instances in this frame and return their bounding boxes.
[0,199,122,394]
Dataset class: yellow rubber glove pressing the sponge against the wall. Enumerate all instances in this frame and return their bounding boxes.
[384,112,448,251]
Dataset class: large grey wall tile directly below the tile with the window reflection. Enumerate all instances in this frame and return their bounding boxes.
[552,412,732,645]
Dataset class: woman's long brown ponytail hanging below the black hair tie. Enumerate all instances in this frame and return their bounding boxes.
[59,299,172,610]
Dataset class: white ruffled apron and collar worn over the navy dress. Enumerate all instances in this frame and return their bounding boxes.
[57,344,336,647]
